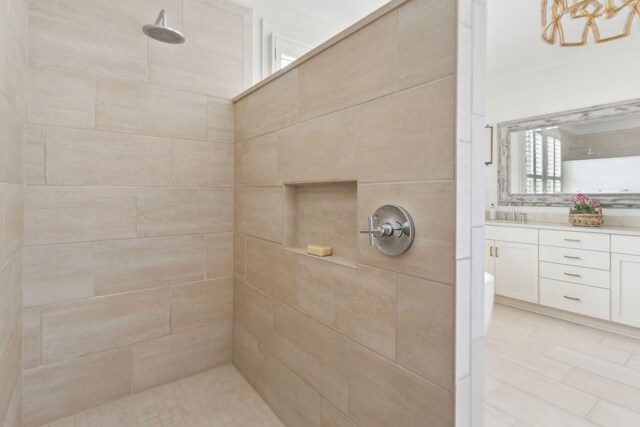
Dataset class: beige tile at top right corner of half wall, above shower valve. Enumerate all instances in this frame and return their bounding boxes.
[398,0,457,89]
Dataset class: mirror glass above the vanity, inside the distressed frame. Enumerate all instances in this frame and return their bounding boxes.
[509,115,640,194]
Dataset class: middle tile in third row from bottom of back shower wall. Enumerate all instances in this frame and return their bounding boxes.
[93,236,205,295]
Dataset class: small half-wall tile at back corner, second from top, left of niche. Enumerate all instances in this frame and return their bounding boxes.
[235,133,281,187]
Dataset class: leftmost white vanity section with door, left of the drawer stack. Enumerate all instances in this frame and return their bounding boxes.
[485,227,539,303]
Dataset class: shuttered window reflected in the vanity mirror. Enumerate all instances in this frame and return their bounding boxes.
[525,129,562,194]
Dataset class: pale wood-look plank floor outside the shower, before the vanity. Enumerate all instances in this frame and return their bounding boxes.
[485,304,640,427]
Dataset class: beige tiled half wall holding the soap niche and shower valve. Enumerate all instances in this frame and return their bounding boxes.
[233,0,457,427]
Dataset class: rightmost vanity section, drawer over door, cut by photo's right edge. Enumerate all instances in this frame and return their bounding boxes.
[611,236,640,328]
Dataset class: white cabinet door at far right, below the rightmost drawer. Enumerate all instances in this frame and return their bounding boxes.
[611,254,640,327]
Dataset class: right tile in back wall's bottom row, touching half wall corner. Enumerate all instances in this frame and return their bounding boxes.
[132,320,232,393]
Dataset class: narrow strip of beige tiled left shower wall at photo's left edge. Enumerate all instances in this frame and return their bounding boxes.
[0,0,26,427]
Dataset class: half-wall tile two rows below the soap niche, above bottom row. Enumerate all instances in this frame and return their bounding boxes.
[274,304,349,412]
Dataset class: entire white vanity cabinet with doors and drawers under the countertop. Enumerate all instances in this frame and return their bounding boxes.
[485,223,640,327]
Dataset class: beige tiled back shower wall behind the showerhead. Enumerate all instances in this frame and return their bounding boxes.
[20,0,251,427]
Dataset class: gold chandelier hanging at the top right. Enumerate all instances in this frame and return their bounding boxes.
[542,0,640,46]
